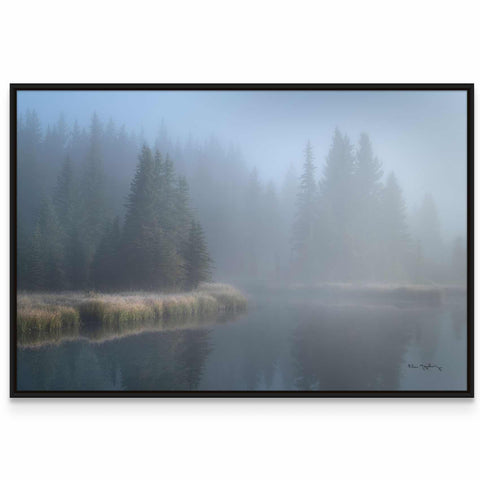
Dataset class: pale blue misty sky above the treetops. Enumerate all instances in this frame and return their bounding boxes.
[18,91,467,235]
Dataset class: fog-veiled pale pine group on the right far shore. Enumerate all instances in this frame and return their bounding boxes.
[292,129,466,283]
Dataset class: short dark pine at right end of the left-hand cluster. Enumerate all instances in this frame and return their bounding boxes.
[184,220,212,289]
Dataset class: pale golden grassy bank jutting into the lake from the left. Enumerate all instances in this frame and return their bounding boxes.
[17,283,247,336]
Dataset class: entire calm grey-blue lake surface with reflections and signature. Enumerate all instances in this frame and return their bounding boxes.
[17,292,467,391]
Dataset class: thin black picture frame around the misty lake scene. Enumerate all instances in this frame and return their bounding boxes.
[10,83,474,398]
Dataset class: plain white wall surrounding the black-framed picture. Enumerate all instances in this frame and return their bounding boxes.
[0,0,480,480]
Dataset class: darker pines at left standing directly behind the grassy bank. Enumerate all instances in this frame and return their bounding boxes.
[18,115,212,291]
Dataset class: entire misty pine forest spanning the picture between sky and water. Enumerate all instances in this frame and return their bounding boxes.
[17,111,466,289]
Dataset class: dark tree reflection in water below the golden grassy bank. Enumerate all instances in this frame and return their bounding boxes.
[18,329,214,390]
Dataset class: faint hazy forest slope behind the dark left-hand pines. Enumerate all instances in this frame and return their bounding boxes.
[17,111,288,288]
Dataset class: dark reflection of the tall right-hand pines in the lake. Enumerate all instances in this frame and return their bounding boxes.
[292,307,414,390]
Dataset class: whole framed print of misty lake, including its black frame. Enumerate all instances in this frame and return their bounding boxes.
[10,84,473,397]
